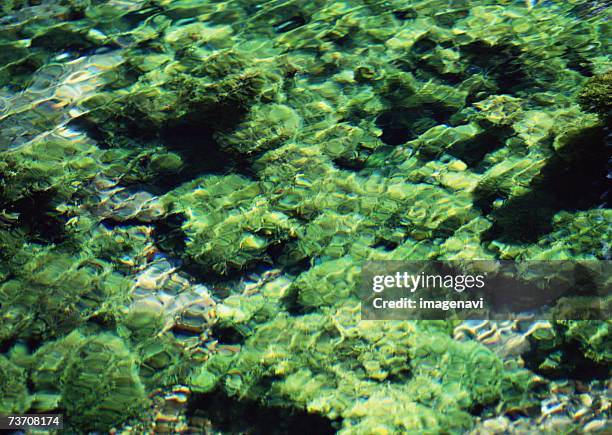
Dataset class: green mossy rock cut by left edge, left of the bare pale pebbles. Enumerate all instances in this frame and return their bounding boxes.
[0,244,130,340]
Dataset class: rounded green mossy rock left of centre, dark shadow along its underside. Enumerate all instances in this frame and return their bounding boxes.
[163,175,296,273]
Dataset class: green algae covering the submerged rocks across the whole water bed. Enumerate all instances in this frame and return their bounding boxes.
[0,0,611,433]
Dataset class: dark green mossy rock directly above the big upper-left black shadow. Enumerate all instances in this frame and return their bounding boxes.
[84,47,284,146]
